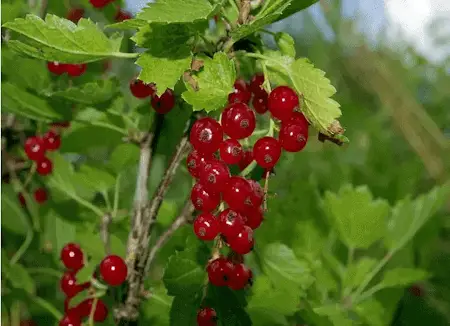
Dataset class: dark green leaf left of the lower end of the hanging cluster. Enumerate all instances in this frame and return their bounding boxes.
[163,253,206,296]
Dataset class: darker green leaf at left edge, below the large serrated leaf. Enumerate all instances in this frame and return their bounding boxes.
[2,83,61,121]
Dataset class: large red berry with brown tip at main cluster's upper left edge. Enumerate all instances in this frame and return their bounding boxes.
[189,117,223,154]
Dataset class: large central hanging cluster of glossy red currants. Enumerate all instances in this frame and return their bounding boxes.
[187,74,309,326]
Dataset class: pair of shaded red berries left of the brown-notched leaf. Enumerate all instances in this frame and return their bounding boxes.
[130,78,175,114]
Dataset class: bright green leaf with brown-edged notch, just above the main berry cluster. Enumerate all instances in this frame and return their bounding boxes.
[182,52,236,112]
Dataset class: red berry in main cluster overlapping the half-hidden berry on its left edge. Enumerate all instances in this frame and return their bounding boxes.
[199,159,230,193]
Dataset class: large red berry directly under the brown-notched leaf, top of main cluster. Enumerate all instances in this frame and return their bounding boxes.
[221,103,256,139]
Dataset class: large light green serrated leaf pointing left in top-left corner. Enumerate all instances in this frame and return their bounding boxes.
[3,14,135,63]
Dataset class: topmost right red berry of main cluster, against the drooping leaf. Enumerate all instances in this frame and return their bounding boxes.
[267,86,299,121]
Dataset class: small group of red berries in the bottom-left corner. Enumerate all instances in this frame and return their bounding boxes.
[59,243,127,326]
